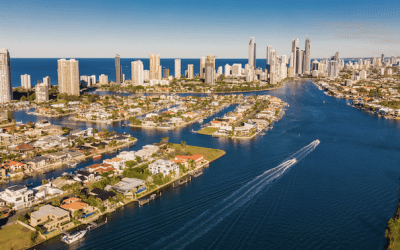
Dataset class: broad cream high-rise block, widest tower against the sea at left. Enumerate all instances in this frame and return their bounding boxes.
[57,59,80,95]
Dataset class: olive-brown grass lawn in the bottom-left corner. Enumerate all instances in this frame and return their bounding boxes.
[0,224,40,250]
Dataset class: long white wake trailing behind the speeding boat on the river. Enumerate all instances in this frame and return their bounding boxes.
[150,140,320,249]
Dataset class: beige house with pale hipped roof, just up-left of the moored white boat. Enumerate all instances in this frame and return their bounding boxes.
[31,205,71,232]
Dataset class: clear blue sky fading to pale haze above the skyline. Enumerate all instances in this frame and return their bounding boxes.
[0,0,400,58]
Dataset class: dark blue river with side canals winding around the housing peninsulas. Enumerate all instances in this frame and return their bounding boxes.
[8,81,400,249]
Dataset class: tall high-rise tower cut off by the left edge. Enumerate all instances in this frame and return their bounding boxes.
[0,49,13,103]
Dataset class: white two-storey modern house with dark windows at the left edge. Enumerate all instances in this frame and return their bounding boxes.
[0,185,35,210]
